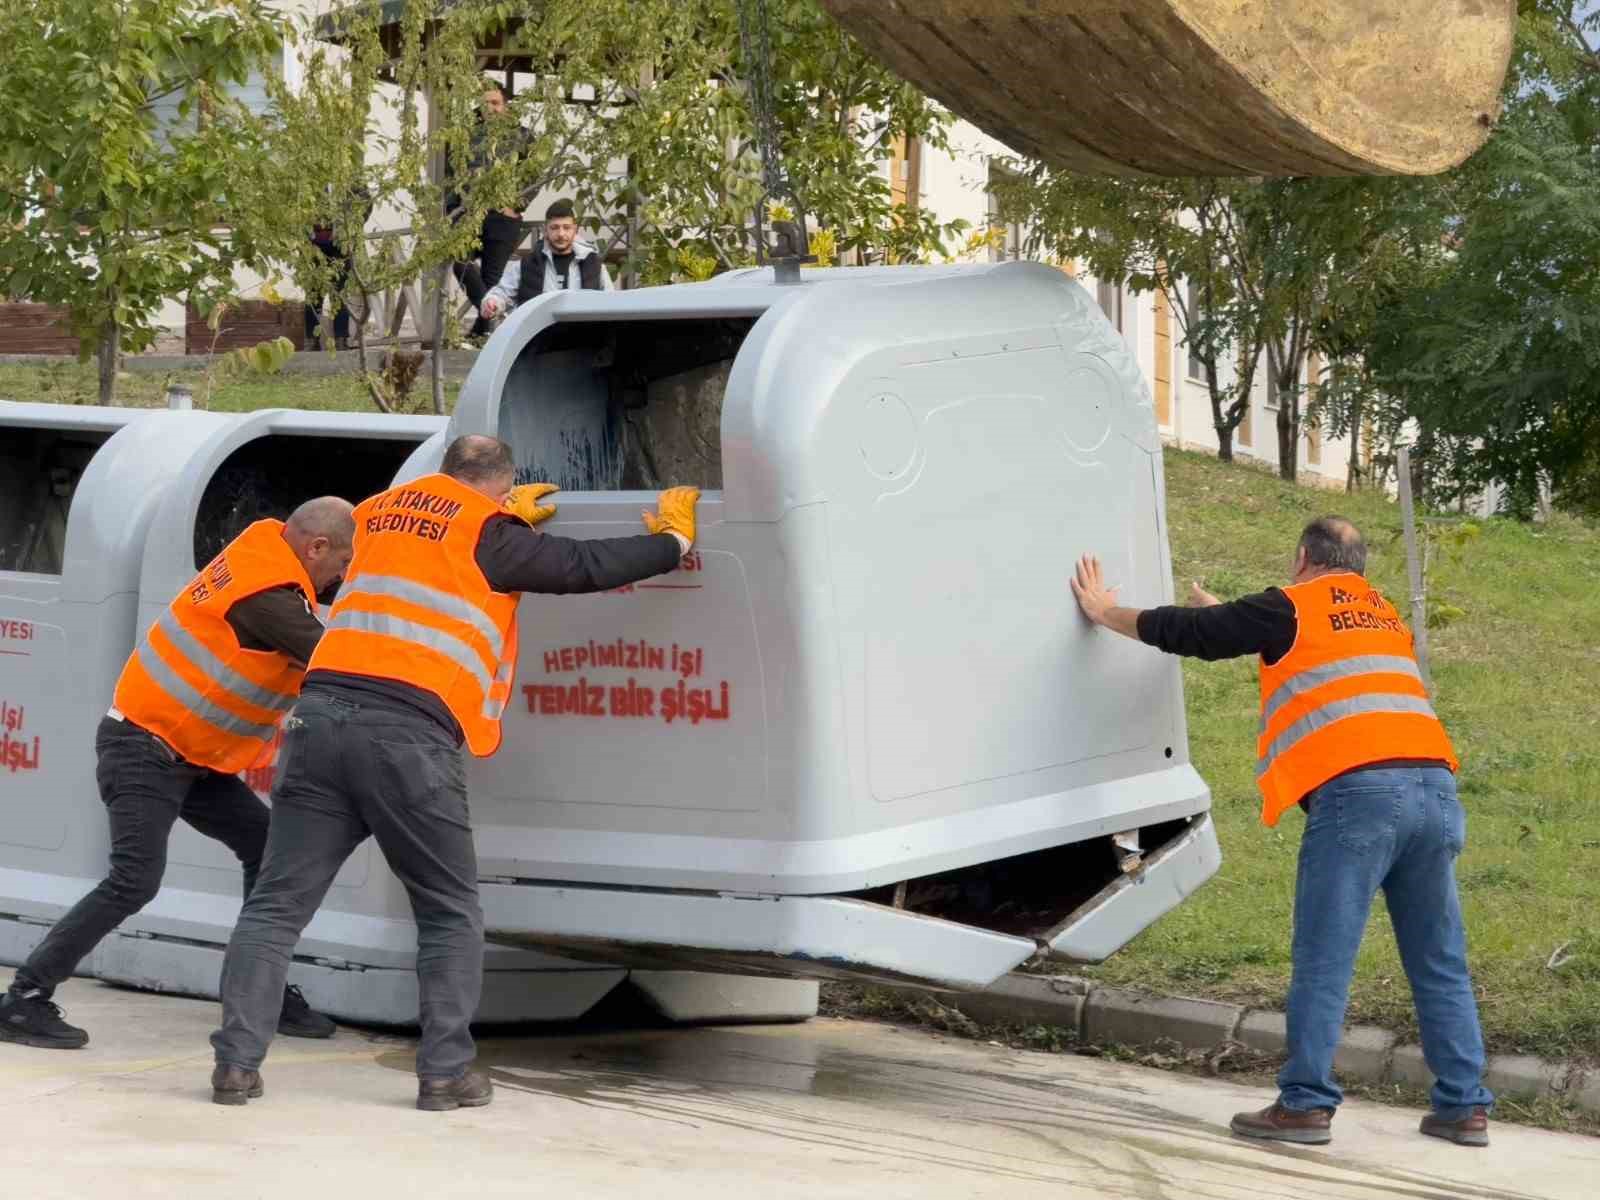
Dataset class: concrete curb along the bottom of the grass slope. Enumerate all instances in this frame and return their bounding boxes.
[938,974,1600,1112]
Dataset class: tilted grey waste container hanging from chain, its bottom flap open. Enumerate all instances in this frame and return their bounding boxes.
[444,264,1219,987]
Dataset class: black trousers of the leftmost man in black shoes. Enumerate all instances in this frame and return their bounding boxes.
[11,717,270,998]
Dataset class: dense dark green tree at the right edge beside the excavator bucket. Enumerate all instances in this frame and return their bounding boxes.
[1371,0,1600,508]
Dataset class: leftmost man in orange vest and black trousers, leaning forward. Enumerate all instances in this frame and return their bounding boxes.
[0,496,354,1050]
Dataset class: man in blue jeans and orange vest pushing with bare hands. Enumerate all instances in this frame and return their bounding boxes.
[1072,517,1494,1146]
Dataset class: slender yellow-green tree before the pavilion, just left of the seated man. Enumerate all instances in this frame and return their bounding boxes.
[248,0,576,413]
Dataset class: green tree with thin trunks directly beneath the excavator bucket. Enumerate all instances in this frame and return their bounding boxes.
[995,163,1442,478]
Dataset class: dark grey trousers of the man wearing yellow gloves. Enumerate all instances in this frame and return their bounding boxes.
[211,685,483,1078]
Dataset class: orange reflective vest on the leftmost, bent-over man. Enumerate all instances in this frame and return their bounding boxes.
[112,520,317,774]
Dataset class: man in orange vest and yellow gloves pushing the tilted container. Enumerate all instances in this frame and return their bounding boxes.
[211,435,699,1110]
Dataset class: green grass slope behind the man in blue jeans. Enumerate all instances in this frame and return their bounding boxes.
[1091,451,1600,1058]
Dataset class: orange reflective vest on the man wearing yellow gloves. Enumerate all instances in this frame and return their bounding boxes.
[310,475,522,757]
